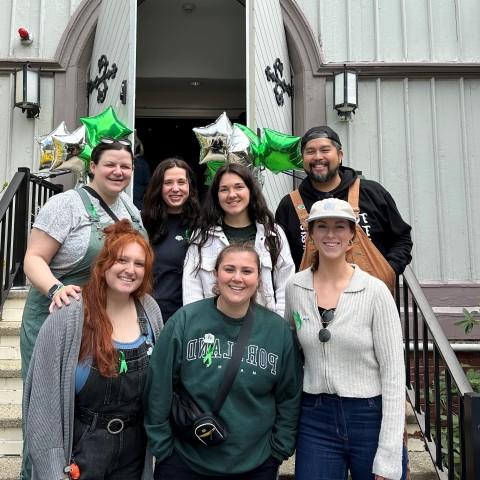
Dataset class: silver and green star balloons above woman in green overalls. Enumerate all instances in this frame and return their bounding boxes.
[36,107,132,170]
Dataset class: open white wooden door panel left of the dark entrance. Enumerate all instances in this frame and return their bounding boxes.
[89,0,137,130]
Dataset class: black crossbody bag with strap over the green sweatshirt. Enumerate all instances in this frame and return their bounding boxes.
[170,308,254,447]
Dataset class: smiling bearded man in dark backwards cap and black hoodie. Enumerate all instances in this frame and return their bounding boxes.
[275,126,412,274]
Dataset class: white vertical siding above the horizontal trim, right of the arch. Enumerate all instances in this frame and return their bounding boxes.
[297,0,480,62]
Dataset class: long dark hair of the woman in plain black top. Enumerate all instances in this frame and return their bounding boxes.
[141,156,199,244]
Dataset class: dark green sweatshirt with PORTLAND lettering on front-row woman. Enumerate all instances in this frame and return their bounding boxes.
[144,298,302,475]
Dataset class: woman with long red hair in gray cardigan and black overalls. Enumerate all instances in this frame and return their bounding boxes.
[23,220,163,480]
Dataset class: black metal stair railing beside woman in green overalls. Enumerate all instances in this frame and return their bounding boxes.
[0,168,63,309]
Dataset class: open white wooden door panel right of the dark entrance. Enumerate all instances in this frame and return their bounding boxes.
[247,0,292,210]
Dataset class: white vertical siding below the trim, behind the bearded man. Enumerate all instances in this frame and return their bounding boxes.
[327,78,480,282]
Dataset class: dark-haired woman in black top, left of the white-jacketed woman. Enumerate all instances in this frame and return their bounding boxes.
[142,157,199,322]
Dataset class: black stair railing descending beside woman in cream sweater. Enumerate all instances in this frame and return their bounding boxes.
[396,267,480,480]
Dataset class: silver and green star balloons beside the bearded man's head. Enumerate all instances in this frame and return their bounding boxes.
[193,112,302,184]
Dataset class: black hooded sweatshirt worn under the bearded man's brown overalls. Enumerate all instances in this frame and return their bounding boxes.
[275,166,413,273]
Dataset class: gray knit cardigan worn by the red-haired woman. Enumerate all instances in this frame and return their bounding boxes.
[23,295,163,480]
